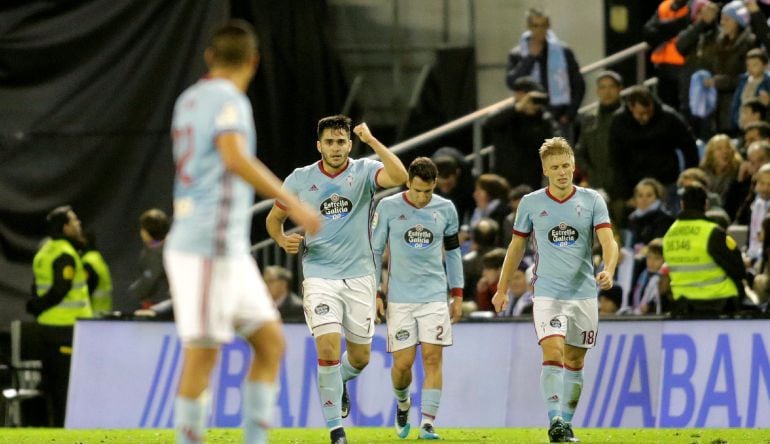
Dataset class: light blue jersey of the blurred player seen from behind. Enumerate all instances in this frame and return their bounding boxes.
[166,78,256,256]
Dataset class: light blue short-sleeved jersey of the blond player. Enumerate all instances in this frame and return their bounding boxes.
[513,187,611,299]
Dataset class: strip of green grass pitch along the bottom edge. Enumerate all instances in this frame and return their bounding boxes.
[0,427,770,444]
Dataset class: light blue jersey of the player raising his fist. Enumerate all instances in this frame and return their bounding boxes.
[276,159,383,279]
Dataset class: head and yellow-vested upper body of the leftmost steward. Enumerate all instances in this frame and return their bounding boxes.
[27,206,93,326]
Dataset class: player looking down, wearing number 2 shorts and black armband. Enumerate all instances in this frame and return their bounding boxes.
[372,157,463,439]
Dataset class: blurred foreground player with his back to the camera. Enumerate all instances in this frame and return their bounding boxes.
[164,21,320,443]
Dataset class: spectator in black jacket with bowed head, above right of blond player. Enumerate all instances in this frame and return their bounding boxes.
[610,86,698,206]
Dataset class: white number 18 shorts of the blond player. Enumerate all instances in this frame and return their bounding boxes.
[532,296,599,348]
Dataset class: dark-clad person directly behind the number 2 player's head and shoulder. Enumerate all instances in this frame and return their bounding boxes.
[431,146,475,224]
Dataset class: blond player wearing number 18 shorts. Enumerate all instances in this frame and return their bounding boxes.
[492,137,618,442]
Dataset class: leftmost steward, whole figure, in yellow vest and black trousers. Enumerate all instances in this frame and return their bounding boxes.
[27,206,93,427]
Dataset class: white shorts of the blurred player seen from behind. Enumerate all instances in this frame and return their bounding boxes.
[163,250,280,346]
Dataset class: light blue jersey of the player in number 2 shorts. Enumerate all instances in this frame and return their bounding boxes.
[372,192,464,303]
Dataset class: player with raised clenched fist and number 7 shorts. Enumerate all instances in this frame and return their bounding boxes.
[267,116,407,443]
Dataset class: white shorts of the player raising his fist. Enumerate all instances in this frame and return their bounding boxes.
[302,275,377,344]
